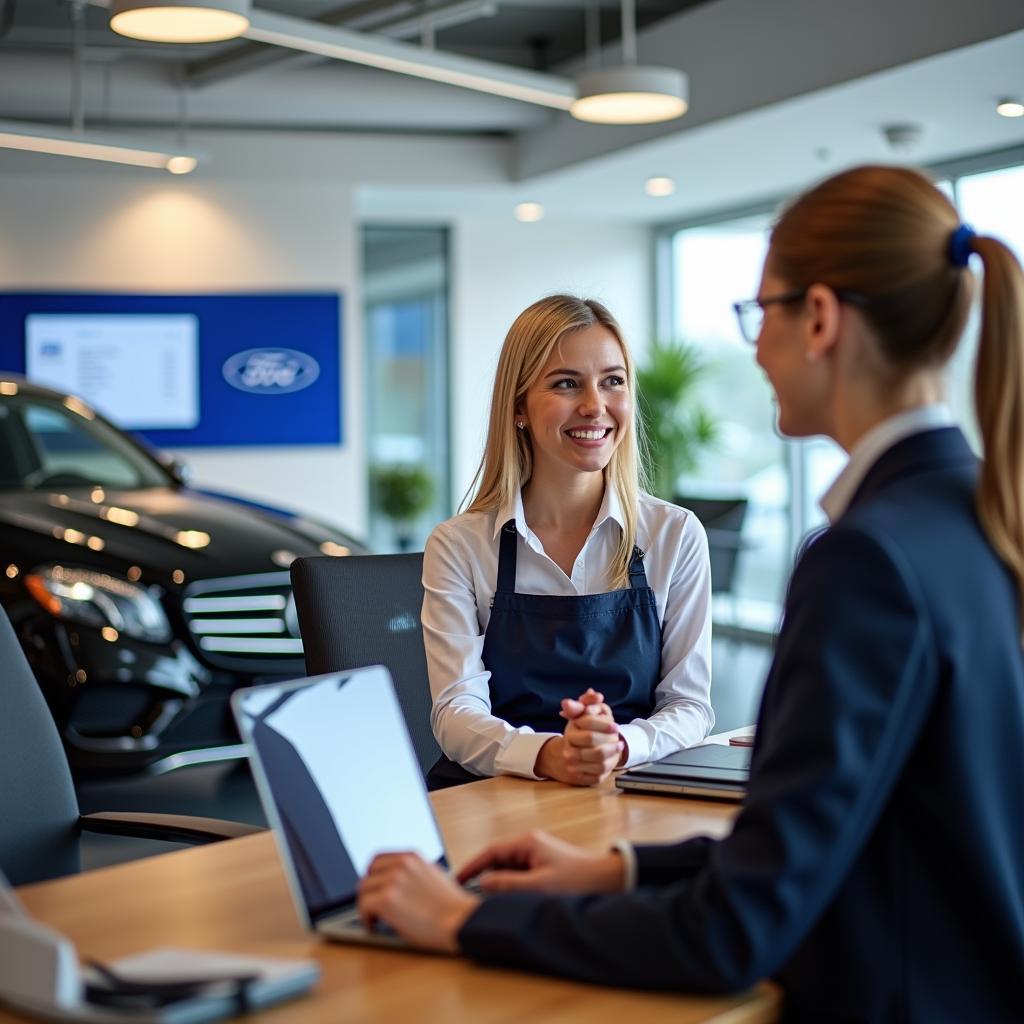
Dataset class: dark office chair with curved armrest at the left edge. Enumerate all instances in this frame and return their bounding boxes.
[0,609,262,885]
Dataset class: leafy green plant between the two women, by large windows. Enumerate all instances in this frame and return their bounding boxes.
[637,342,718,502]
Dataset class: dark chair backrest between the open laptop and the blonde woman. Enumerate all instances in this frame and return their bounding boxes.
[292,552,440,774]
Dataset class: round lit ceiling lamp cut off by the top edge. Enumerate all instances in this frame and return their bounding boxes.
[111,0,251,43]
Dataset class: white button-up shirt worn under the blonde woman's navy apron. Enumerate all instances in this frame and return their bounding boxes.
[422,487,715,778]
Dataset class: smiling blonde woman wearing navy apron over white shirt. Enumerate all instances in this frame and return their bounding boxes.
[422,295,715,788]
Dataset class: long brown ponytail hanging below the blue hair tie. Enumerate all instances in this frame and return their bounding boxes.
[972,238,1024,630]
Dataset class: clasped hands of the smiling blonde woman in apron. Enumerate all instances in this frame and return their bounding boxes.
[534,689,627,785]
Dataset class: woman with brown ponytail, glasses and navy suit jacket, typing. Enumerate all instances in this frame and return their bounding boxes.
[361,167,1024,1024]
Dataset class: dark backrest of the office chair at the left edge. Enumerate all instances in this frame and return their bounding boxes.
[0,608,81,886]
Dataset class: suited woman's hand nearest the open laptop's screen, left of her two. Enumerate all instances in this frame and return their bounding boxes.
[358,853,480,953]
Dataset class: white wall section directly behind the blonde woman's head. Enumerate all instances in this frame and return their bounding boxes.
[452,215,653,503]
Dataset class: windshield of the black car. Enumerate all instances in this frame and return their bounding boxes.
[0,395,170,490]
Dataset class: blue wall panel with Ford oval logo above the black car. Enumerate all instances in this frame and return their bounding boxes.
[0,290,344,446]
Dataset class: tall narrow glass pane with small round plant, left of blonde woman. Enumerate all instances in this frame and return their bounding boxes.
[362,227,451,551]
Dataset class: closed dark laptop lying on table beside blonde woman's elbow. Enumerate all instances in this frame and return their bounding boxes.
[615,743,751,801]
